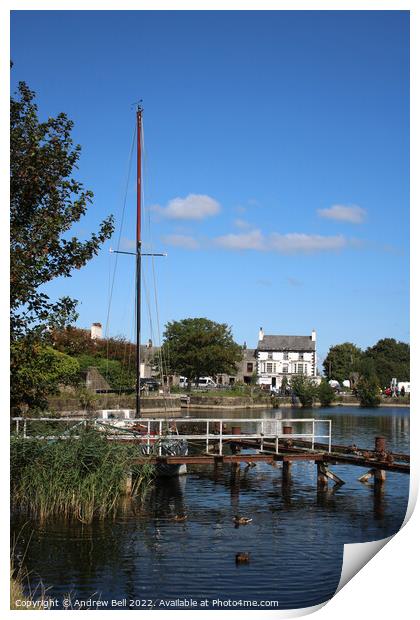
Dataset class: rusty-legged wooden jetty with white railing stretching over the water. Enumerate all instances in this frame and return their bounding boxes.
[13,418,410,488]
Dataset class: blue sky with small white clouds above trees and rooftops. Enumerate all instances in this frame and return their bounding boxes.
[11,11,409,364]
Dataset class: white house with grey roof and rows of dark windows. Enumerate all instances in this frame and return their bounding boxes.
[256,327,317,388]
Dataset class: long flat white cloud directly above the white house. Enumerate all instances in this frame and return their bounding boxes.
[269,233,347,254]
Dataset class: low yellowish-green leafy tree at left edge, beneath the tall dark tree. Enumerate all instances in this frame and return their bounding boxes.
[11,340,80,409]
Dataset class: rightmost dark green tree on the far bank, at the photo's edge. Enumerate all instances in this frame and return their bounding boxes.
[363,338,410,387]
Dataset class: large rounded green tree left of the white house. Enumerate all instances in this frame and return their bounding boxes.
[162,318,242,384]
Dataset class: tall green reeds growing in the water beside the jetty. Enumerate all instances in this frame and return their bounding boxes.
[11,429,154,523]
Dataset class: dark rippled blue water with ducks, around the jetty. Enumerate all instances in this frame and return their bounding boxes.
[13,407,409,609]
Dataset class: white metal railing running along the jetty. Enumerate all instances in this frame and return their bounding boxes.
[12,411,331,455]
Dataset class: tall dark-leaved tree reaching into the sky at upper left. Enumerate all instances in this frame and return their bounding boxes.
[10,82,113,340]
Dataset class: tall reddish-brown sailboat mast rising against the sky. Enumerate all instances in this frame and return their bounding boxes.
[136,106,143,418]
